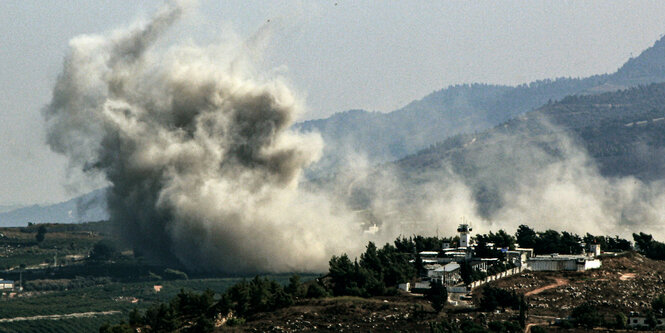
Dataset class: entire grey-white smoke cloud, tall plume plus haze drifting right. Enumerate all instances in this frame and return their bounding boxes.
[44,1,665,272]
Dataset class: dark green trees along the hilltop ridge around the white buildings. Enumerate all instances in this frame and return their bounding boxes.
[100,225,665,333]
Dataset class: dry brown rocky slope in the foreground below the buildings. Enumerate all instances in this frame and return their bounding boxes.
[220,253,665,332]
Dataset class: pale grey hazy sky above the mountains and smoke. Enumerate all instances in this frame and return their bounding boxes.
[0,0,665,205]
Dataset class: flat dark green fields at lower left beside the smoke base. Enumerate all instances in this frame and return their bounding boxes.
[0,223,315,332]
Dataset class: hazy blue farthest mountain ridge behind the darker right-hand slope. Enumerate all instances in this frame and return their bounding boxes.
[294,34,665,177]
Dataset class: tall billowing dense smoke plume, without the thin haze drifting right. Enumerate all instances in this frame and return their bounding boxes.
[44,5,363,272]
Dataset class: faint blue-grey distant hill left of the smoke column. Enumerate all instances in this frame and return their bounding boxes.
[0,189,108,227]
